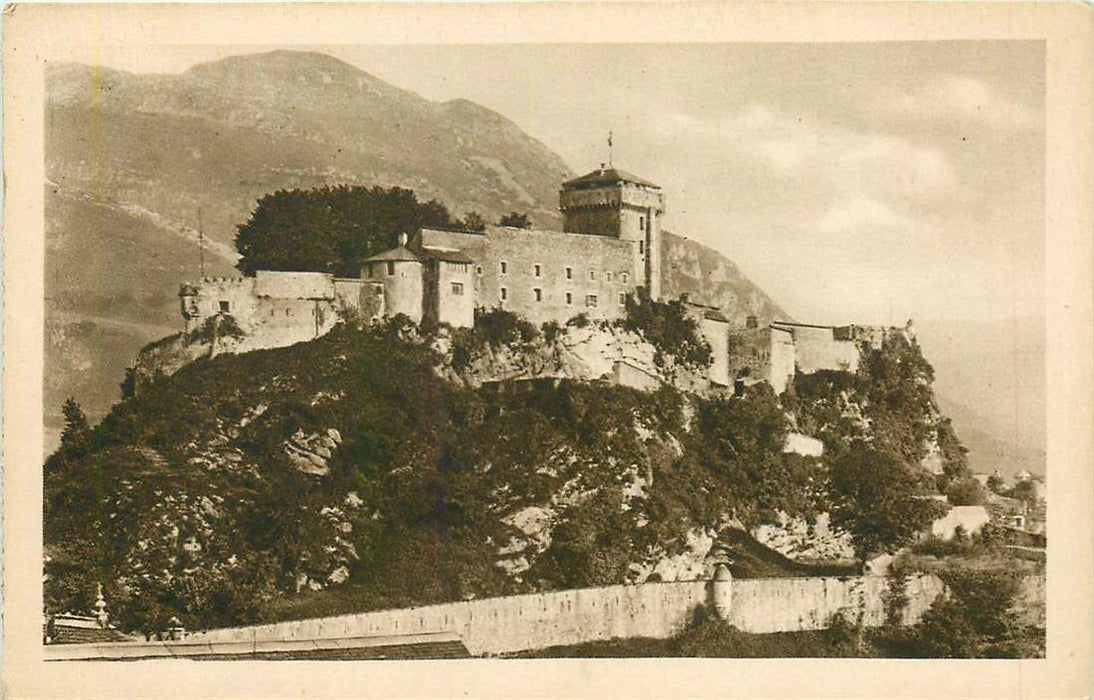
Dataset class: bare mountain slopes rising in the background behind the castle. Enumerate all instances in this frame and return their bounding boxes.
[45,51,779,455]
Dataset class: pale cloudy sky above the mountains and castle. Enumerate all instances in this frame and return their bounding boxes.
[63,42,1045,324]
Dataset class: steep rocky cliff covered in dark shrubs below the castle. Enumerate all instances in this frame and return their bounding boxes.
[45,319,961,630]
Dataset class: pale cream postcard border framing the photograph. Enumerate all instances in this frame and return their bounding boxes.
[3,2,1094,698]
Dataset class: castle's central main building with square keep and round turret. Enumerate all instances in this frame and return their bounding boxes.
[362,167,664,326]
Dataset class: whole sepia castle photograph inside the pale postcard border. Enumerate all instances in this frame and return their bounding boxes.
[5,2,1089,695]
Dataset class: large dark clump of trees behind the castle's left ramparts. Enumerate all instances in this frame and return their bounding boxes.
[235,185,453,277]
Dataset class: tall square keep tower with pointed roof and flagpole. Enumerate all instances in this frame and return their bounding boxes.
[559,170,665,300]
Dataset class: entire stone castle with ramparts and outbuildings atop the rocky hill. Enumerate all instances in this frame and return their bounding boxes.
[172,165,910,393]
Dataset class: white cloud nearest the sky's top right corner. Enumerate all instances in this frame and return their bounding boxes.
[882,74,1043,130]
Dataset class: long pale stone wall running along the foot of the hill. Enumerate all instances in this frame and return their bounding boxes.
[175,569,943,655]
